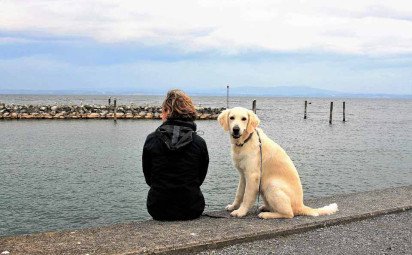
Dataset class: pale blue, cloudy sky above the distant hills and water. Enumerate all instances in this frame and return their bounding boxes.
[0,0,412,95]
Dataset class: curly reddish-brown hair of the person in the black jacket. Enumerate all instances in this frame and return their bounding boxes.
[162,89,197,120]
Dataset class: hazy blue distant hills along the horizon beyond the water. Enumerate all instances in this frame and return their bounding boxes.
[0,86,412,99]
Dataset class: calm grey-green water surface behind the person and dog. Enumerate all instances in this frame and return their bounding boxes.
[0,95,412,236]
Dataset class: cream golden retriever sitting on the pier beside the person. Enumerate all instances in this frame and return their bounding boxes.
[218,107,338,219]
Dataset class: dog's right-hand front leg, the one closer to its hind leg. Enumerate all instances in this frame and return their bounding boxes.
[230,174,259,217]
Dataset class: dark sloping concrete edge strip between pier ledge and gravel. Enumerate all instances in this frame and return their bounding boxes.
[140,205,412,255]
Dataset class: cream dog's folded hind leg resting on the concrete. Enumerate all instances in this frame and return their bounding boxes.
[259,187,294,219]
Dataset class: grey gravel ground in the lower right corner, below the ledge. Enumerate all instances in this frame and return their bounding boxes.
[196,210,412,255]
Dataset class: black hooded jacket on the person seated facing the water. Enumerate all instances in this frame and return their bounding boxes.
[143,119,209,220]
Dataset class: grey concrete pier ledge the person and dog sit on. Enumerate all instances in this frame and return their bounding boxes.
[0,186,412,255]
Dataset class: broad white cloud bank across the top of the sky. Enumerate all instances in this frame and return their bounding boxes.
[0,0,412,55]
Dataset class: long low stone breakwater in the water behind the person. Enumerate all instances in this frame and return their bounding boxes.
[0,103,224,120]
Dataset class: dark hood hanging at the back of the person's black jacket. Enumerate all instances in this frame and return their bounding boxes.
[156,119,196,151]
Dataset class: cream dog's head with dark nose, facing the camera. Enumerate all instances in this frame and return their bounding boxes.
[217,107,260,139]
